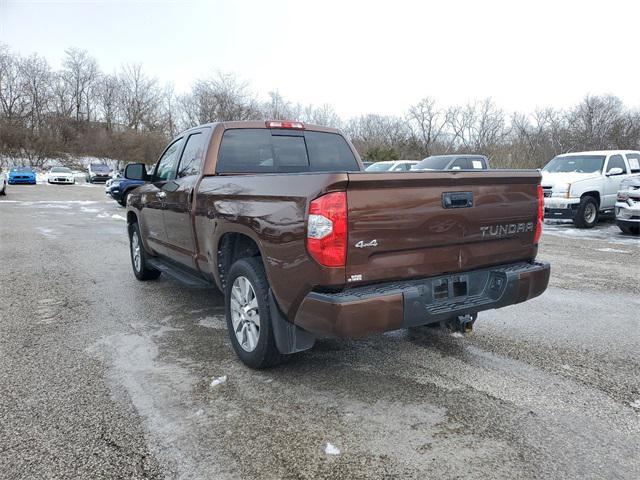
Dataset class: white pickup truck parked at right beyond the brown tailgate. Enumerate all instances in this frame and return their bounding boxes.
[542,150,640,228]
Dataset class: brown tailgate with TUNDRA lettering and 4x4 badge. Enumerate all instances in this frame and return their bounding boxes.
[346,170,540,283]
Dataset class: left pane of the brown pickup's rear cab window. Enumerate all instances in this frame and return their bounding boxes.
[216,128,275,173]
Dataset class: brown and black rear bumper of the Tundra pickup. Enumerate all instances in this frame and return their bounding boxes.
[294,262,550,337]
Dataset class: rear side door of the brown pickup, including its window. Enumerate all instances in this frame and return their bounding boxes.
[163,128,211,269]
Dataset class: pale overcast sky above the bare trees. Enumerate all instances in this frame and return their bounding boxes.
[0,0,640,117]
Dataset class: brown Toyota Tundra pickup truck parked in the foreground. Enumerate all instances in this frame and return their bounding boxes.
[125,121,549,368]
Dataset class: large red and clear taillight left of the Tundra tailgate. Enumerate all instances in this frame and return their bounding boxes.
[307,192,347,267]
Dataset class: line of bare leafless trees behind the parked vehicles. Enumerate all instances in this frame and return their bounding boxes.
[0,45,640,168]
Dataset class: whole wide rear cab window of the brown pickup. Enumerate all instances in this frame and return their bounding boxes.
[216,128,360,173]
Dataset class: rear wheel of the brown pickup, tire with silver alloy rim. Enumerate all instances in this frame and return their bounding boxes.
[224,257,283,369]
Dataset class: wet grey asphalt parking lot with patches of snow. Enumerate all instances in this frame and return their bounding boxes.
[0,183,640,479]
